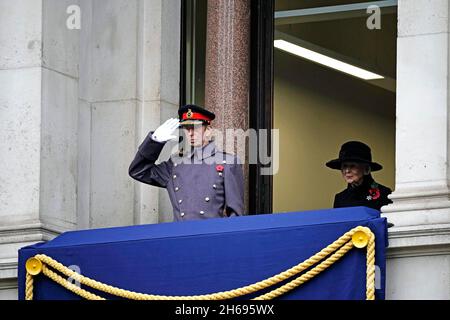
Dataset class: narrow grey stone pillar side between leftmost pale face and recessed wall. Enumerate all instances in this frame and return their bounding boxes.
[40,0,80,232]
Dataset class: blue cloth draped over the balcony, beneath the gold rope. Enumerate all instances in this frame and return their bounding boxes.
[18,207,388,300]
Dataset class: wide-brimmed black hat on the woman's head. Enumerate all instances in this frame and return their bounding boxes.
[326,141,383,171]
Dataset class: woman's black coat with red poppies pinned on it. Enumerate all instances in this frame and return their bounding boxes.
[333,175,392,210]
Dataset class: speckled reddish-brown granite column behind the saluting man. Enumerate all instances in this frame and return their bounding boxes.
[205,0,250,215]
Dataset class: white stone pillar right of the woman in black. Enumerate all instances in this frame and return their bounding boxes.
[382,0,450,299]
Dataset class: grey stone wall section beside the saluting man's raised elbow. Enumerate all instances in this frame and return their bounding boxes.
[77,0,180,228]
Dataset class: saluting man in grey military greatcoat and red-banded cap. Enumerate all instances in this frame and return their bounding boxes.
[129,105,244,221]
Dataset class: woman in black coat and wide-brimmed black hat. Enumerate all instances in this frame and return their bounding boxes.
[326,141,392,210]
